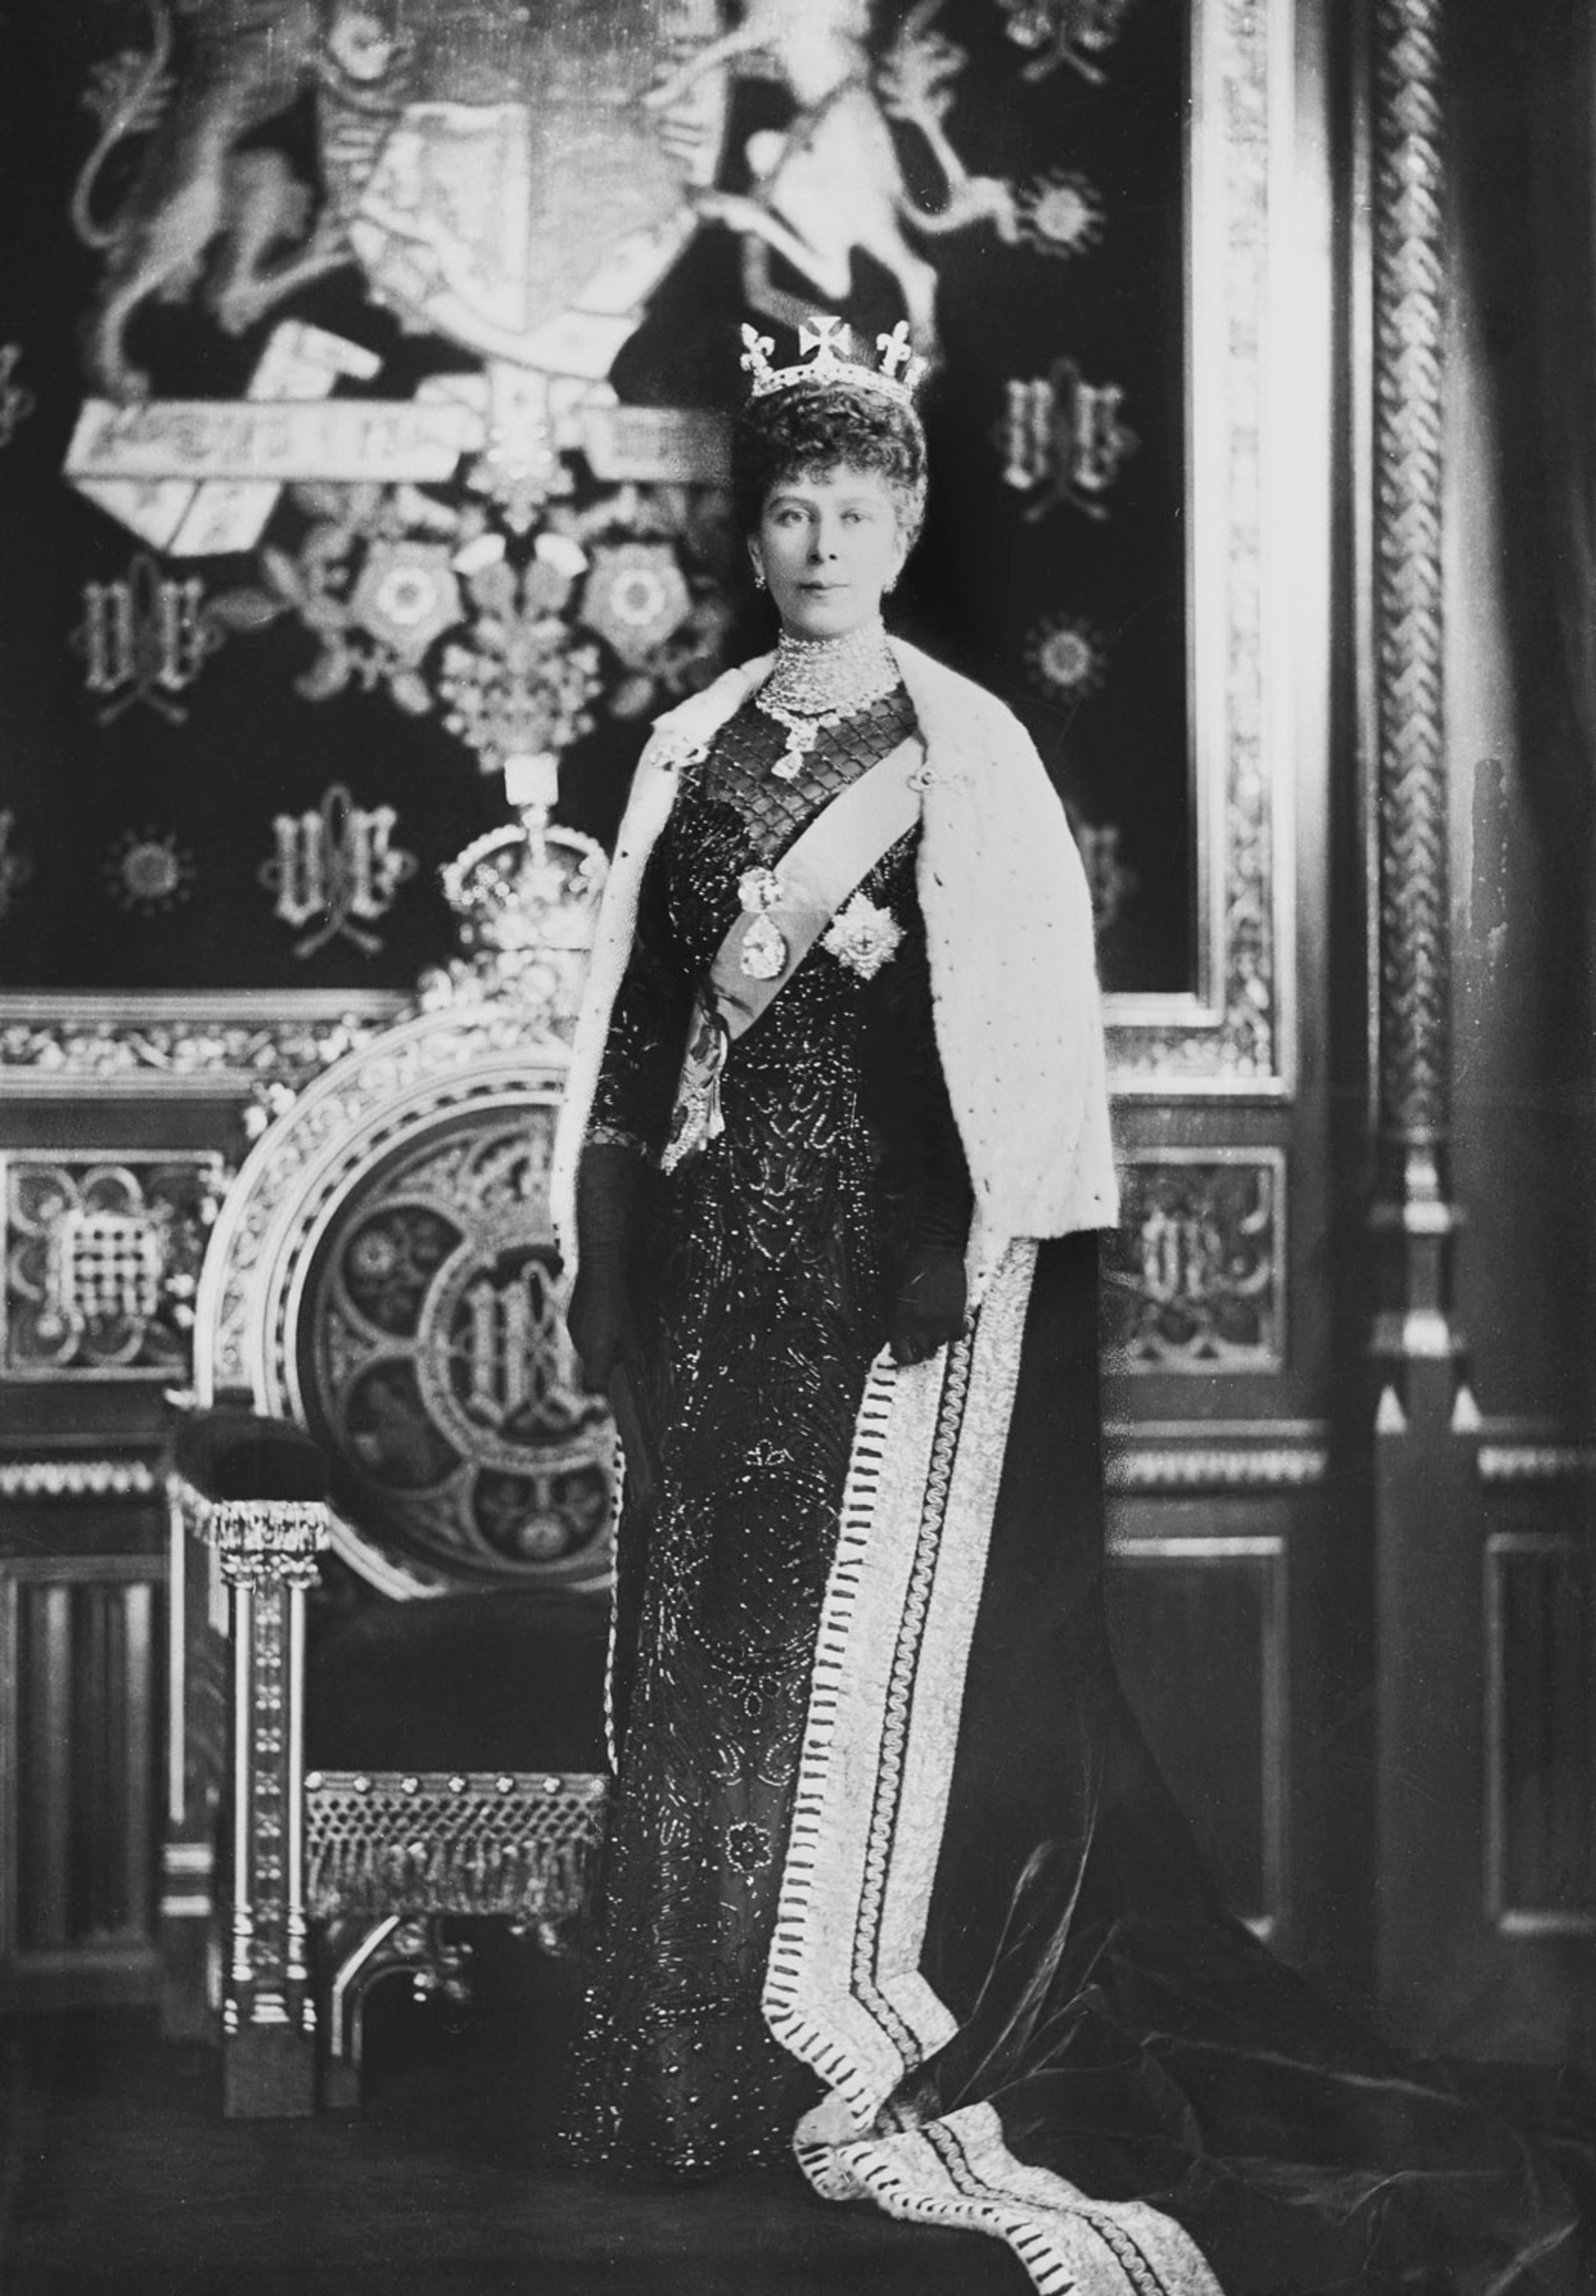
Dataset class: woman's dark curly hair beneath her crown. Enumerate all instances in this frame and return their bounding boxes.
[733,383,926,544]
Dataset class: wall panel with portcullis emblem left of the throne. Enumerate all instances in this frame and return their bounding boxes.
[0,1153,225,1380]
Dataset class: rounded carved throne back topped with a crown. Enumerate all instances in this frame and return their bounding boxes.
[195,831,613,1596]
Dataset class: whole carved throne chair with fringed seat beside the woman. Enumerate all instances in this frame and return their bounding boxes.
[163,817,616,2115]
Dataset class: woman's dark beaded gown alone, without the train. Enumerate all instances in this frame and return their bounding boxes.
[567,689,969,2174]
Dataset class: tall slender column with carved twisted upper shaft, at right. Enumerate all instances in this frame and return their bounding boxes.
[1369,0,1483,2043]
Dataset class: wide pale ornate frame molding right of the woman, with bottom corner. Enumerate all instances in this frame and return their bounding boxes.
[1107,0,1304,1100]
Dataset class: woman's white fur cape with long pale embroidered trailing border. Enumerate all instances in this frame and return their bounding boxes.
[554,647,1175,2296]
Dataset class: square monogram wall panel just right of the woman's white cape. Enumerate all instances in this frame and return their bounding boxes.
[1105,1148,1286,1375]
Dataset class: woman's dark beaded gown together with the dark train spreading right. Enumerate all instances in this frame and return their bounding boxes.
[563,693,1596,2296]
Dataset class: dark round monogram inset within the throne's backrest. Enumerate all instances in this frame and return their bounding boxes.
[301,1107,611,1573]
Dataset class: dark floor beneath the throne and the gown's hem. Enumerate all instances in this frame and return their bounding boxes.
[0,1938,1029,2296]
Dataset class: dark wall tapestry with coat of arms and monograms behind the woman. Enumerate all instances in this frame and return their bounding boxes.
[0,0,1194,992]
